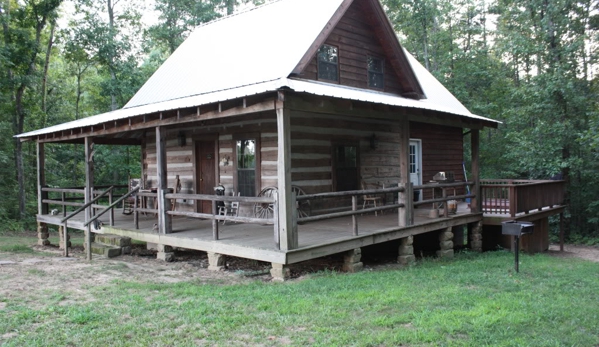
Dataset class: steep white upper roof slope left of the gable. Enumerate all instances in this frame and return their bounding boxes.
[125,0,343,108]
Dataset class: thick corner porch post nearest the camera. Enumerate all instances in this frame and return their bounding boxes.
[276,92,298,250]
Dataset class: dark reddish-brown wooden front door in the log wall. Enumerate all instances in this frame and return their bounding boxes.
[195,141,216,213]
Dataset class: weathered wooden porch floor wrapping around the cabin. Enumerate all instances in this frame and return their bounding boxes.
[38,203,482,264]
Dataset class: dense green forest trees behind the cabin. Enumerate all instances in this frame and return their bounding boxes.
[0,0,599,243]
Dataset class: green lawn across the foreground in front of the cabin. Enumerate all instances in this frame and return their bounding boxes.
[0,252,599,346]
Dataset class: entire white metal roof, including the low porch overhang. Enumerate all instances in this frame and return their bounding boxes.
[17,0,499,138]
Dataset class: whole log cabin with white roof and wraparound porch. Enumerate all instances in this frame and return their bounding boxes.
[18,0,563,279]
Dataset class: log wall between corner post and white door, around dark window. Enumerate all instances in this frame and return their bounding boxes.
[291,111,399,203]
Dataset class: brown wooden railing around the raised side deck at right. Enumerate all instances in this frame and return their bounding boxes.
[481,180,566,217]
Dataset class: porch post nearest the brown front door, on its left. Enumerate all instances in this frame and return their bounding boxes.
[156,126,172,234]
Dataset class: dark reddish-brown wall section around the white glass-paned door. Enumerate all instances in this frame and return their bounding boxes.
[410,123,472,199]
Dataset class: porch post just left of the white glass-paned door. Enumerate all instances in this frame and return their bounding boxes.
[398,119,412,227]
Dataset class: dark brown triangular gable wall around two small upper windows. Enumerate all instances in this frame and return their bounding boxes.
[301,1,402,94]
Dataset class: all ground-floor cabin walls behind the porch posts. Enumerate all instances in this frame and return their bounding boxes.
[143,111,464,215]
